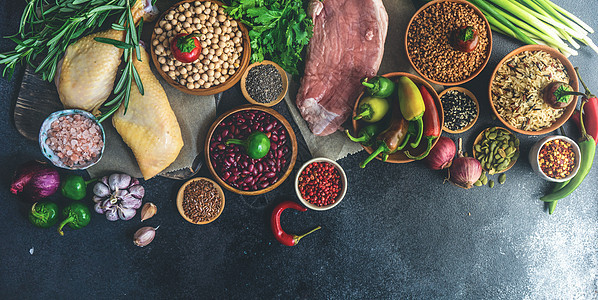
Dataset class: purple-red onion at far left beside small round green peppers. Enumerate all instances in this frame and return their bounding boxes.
[10,160,60,202]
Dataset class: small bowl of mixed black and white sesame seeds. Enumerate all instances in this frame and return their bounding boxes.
[438,87,480,133]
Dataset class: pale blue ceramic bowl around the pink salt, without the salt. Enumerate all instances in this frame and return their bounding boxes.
[39,109,106,170]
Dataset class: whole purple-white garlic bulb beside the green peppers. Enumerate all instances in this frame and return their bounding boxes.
[92,173,145,221]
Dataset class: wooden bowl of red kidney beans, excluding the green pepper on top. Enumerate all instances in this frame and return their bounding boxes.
[204,105,297,195]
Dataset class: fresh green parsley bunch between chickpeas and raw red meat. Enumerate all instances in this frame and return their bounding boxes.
[226,0,313,75]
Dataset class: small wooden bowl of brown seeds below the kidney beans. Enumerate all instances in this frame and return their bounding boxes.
[176,177,224,225]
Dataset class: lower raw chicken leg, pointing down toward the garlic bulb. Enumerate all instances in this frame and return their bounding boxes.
[112,50,183,180]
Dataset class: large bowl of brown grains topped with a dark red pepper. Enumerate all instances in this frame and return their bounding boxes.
[405,0,492,85]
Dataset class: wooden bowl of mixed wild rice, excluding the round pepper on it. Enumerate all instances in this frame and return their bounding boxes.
[489,45,579,135]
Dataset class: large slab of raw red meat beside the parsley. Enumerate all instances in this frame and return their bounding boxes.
[297,0,388,135]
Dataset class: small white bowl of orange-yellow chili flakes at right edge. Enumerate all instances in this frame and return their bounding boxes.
[529,135,581,182]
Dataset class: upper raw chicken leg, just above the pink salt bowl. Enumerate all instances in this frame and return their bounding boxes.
[55,0,157,114]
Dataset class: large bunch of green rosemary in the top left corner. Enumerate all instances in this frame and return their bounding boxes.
[0,0,128,81]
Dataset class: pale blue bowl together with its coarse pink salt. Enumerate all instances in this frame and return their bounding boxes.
[39,109,106,170]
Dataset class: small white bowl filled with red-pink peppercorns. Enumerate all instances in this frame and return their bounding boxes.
[295,157,347,210]
